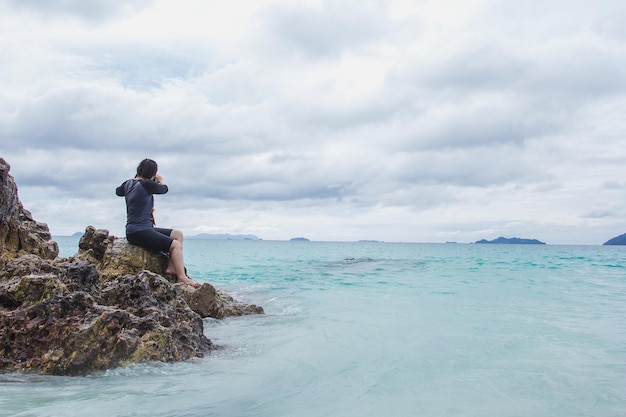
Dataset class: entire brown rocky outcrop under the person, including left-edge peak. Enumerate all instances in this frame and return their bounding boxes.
[0,158,263,375]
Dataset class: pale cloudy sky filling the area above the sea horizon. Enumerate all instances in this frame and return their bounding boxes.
[0,0,626,245]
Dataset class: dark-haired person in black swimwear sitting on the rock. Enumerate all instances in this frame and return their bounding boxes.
[115,159,200,287]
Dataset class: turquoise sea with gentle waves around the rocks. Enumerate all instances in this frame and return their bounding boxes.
[0,238,626,417]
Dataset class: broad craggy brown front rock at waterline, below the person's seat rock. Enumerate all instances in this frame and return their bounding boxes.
[0,255,213,375]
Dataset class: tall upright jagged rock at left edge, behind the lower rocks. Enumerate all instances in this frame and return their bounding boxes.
[0,158,59,268]
